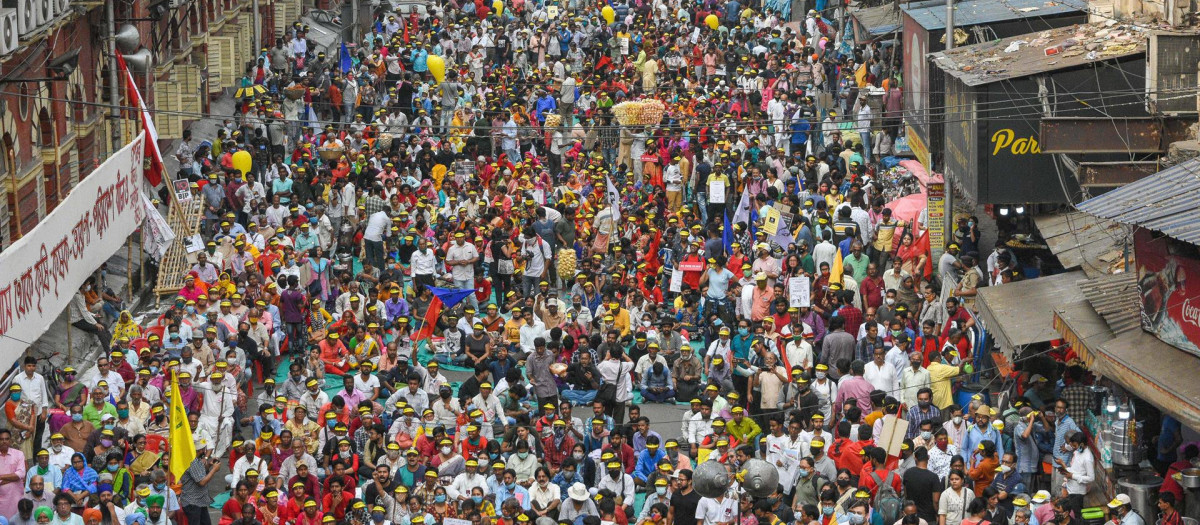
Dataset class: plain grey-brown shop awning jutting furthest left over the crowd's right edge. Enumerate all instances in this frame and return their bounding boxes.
[976,271,1085,350]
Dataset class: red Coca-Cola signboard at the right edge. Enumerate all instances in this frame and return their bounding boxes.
[1134,229,1200,355]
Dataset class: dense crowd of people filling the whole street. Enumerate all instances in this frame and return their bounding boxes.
[9,0,1161,525]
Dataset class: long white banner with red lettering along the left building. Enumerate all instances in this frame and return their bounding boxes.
[0,134,145,361]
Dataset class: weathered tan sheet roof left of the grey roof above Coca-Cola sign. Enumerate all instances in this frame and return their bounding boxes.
[1033,211,1132,277]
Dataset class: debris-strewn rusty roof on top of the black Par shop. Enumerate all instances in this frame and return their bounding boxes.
[930,19,1147,86]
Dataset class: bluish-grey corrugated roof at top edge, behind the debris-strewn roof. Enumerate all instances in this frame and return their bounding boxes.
[901,0,1087,31]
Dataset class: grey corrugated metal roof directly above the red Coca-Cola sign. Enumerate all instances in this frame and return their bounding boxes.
[1076,158,1200,245]
